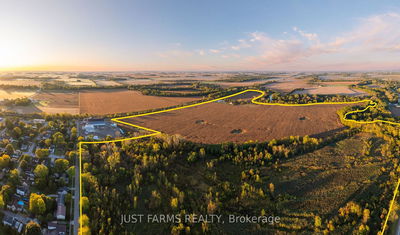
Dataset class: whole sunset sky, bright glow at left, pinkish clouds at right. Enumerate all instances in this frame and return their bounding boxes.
[0,0,400,71]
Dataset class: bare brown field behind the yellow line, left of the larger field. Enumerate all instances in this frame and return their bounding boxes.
[79,90,199,114]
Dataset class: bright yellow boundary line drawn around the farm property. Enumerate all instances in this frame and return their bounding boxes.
[78,89,400,234]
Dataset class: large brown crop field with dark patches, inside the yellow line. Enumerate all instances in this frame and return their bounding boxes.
[125,101,354,143]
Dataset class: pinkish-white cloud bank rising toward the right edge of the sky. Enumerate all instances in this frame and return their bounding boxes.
[245,13,400,68]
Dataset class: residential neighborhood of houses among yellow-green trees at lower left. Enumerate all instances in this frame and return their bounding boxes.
[0,117,77,235]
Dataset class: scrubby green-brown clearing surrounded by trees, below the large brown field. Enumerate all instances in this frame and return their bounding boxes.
[261,134,385,215]
